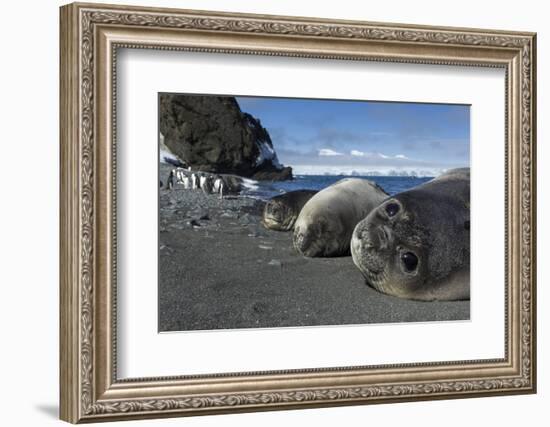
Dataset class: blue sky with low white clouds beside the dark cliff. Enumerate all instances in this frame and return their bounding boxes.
[236,97,470,173]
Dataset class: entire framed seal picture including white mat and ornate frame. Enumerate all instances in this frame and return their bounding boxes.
[59,3,537,423]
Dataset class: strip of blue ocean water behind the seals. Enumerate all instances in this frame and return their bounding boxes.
[242,175,432,200]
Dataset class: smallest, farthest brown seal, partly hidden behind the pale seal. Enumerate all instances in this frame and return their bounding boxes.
[262,190,318,231]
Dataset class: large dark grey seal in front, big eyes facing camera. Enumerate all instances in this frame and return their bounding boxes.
[351,168,470,301]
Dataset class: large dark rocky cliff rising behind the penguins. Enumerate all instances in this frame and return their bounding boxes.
[160,94,292,180]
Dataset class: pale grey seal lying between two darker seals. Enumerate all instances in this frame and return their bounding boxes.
[292,178,388,257]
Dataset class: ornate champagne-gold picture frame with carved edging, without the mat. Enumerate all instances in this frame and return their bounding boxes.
[60,4,536,423]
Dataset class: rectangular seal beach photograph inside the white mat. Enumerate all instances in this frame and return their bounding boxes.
[158,93,470,332]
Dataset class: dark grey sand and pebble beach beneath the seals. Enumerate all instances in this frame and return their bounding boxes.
[158,165,470,332]
